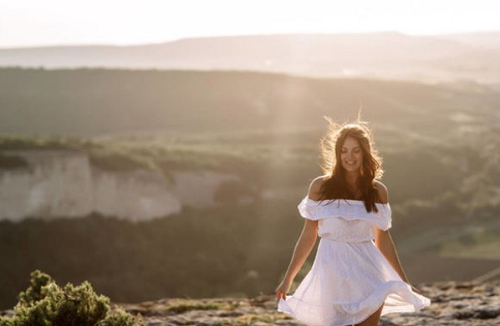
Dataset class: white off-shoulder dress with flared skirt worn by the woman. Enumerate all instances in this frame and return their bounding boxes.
[277,196,431,326]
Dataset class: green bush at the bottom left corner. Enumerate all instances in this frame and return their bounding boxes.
[0,270,144,326]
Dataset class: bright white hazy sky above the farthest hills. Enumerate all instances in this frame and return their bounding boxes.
[0,0,500,48]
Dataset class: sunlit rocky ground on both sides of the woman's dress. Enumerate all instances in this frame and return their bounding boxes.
[113,280,500,326]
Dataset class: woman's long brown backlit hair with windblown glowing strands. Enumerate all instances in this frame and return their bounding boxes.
[320,115,384,212]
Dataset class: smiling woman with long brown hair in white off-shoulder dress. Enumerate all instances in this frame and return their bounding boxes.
[276,117,431,326]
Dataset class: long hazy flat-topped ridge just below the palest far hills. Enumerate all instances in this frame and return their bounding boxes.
[0,68,500,137]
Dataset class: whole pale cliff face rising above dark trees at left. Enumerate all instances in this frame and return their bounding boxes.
[0,150,238,221]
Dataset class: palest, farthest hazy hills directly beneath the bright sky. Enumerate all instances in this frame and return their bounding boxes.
[0,32,500,83]
